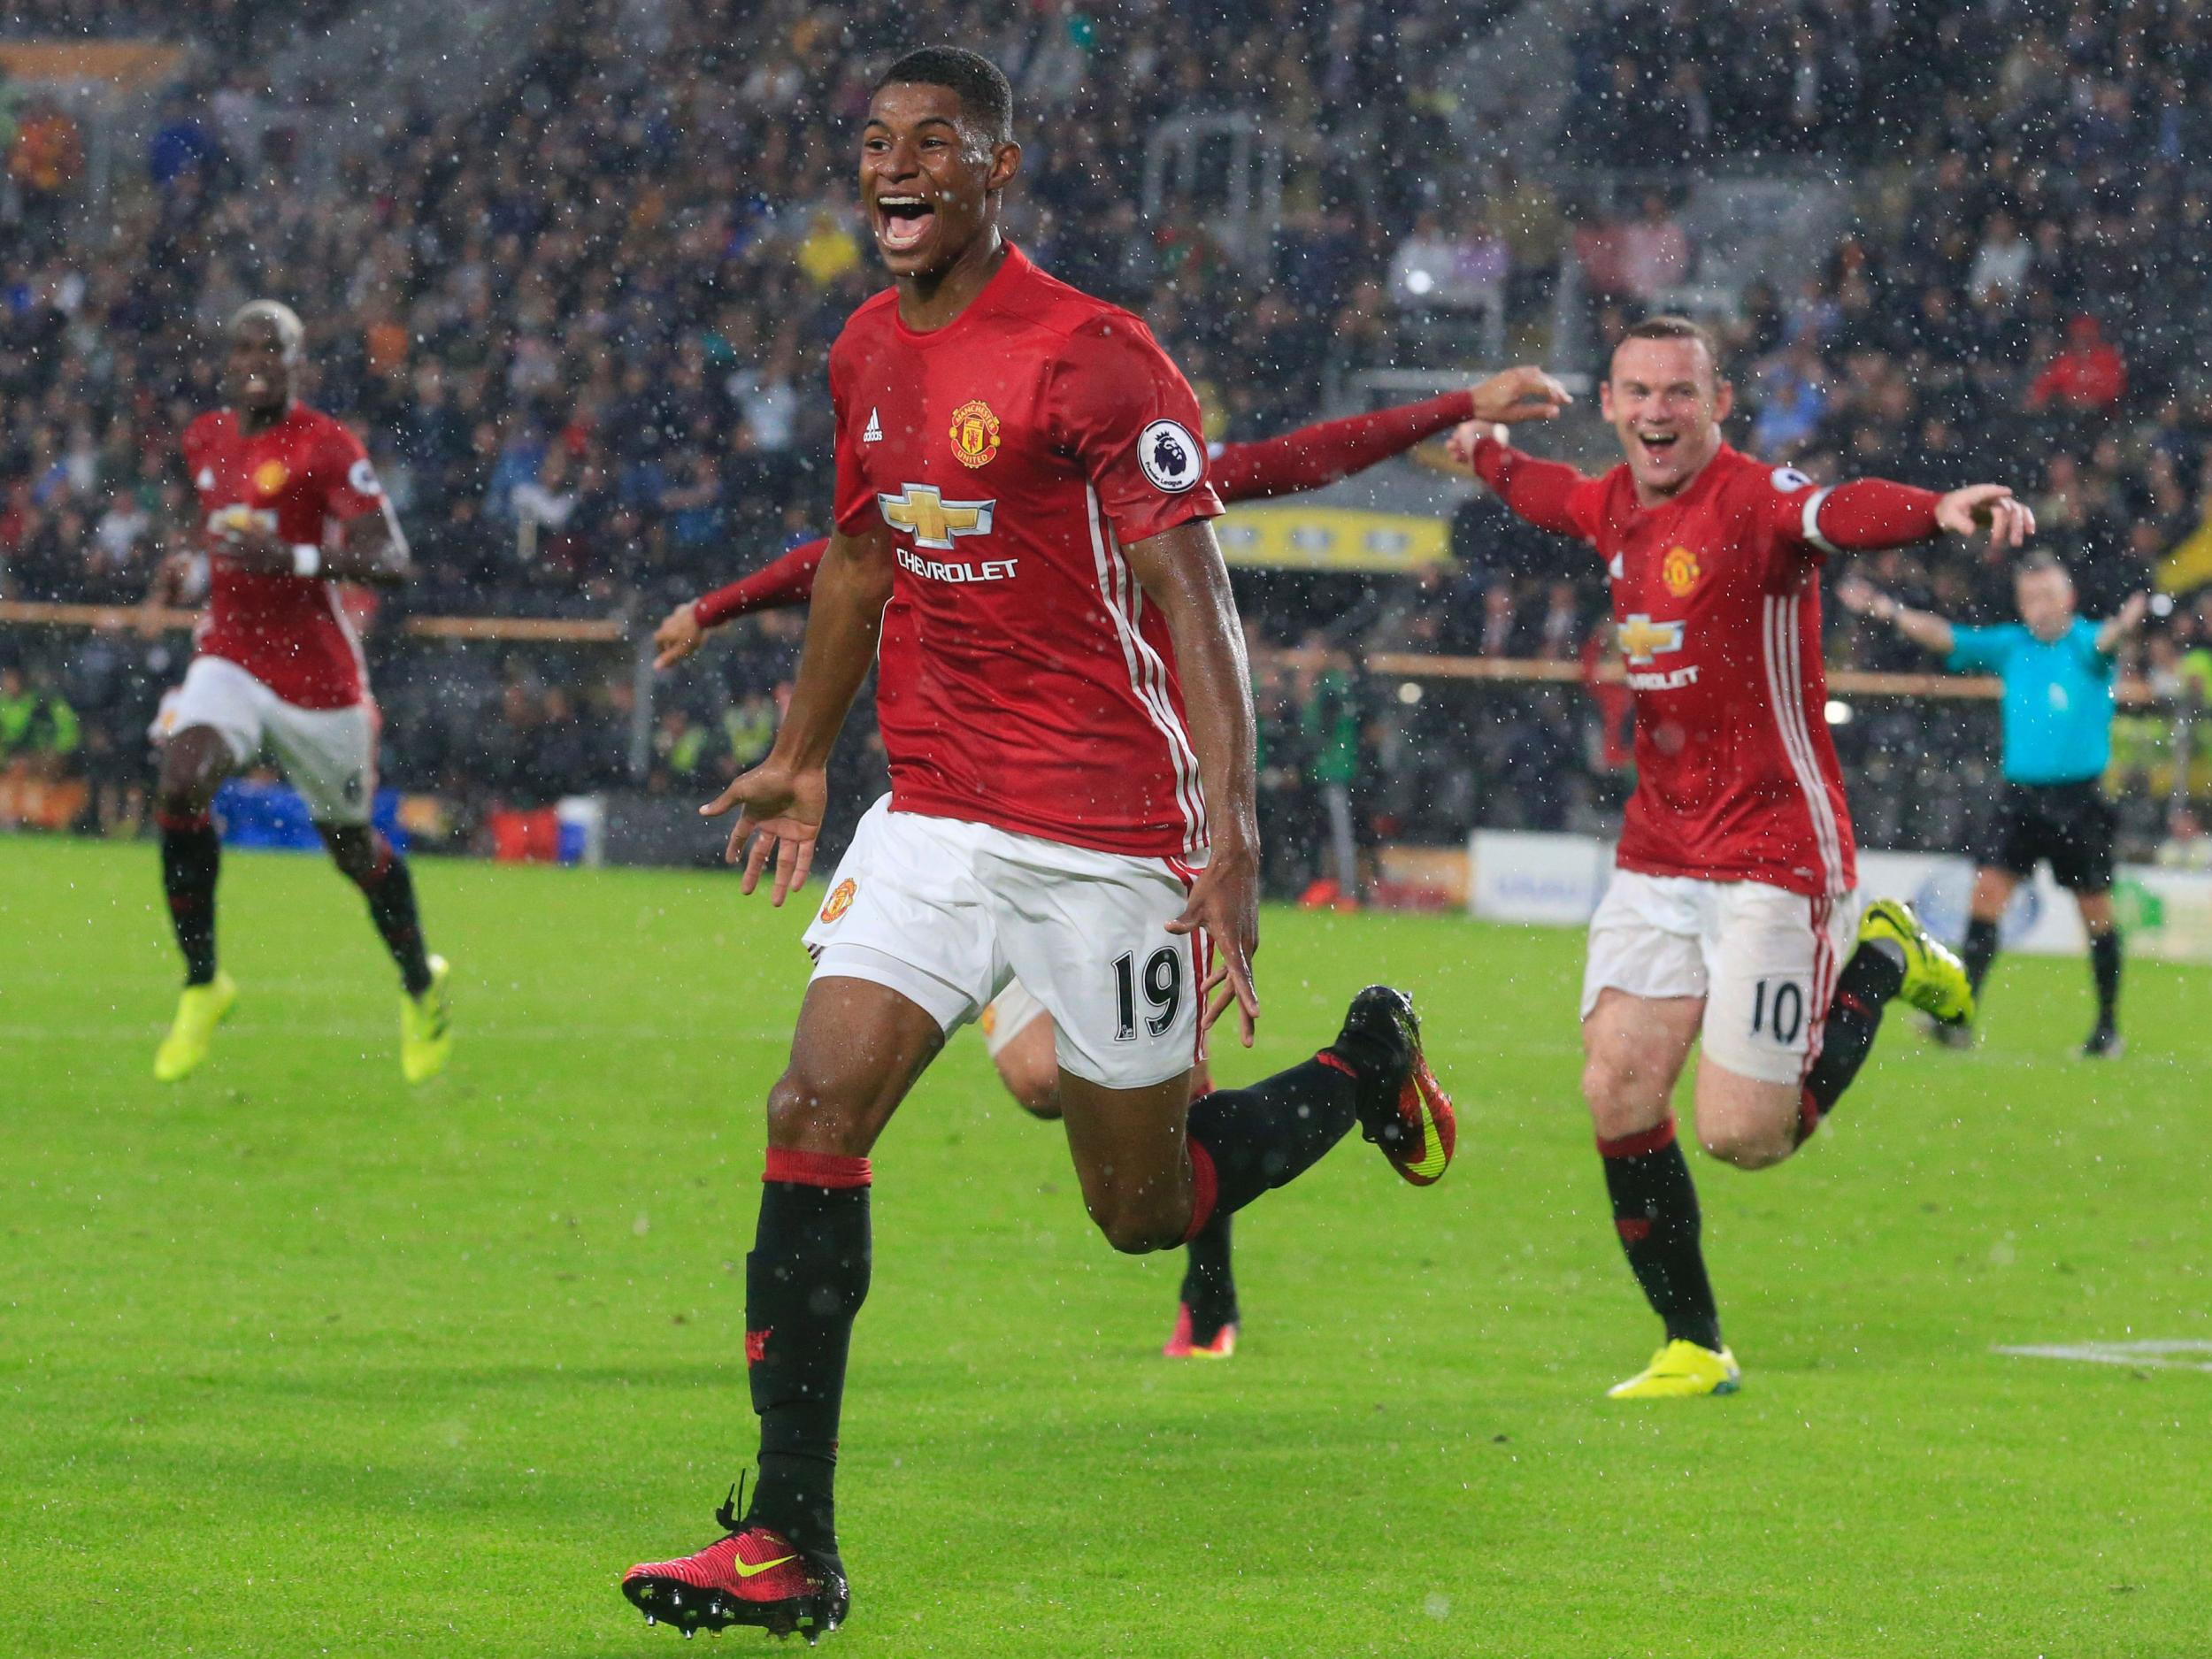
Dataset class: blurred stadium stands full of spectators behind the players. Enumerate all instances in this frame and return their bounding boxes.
[0,0,2212,925]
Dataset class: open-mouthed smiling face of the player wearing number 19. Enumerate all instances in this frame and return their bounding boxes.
[861,82,1022,286]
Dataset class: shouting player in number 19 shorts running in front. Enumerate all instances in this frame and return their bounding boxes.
[624,49,1454,1635]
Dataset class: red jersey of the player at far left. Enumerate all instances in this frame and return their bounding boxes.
[184,403,385,708]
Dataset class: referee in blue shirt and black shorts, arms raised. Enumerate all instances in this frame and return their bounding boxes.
[1836,553,2148,1060]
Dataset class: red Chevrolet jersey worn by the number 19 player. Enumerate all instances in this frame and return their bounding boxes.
[830,250,1221,856]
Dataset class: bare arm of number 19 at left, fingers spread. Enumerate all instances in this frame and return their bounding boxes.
[699,529,894,905]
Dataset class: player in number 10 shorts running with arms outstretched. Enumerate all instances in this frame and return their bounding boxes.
[1454,317,2033,1398]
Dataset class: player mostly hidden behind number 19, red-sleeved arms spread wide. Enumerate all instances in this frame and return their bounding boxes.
[653,392,1480,1361]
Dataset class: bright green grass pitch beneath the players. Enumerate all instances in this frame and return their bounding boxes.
[0,841,2212,1659]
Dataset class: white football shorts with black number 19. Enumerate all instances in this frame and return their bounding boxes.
[805,796,1203,1088]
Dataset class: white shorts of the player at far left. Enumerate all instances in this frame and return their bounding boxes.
[159,657,376,826]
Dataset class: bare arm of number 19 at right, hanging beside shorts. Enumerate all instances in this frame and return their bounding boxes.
[1128,518,1259,1048]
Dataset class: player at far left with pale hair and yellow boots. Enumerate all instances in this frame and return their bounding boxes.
[150,299,454,1084]
